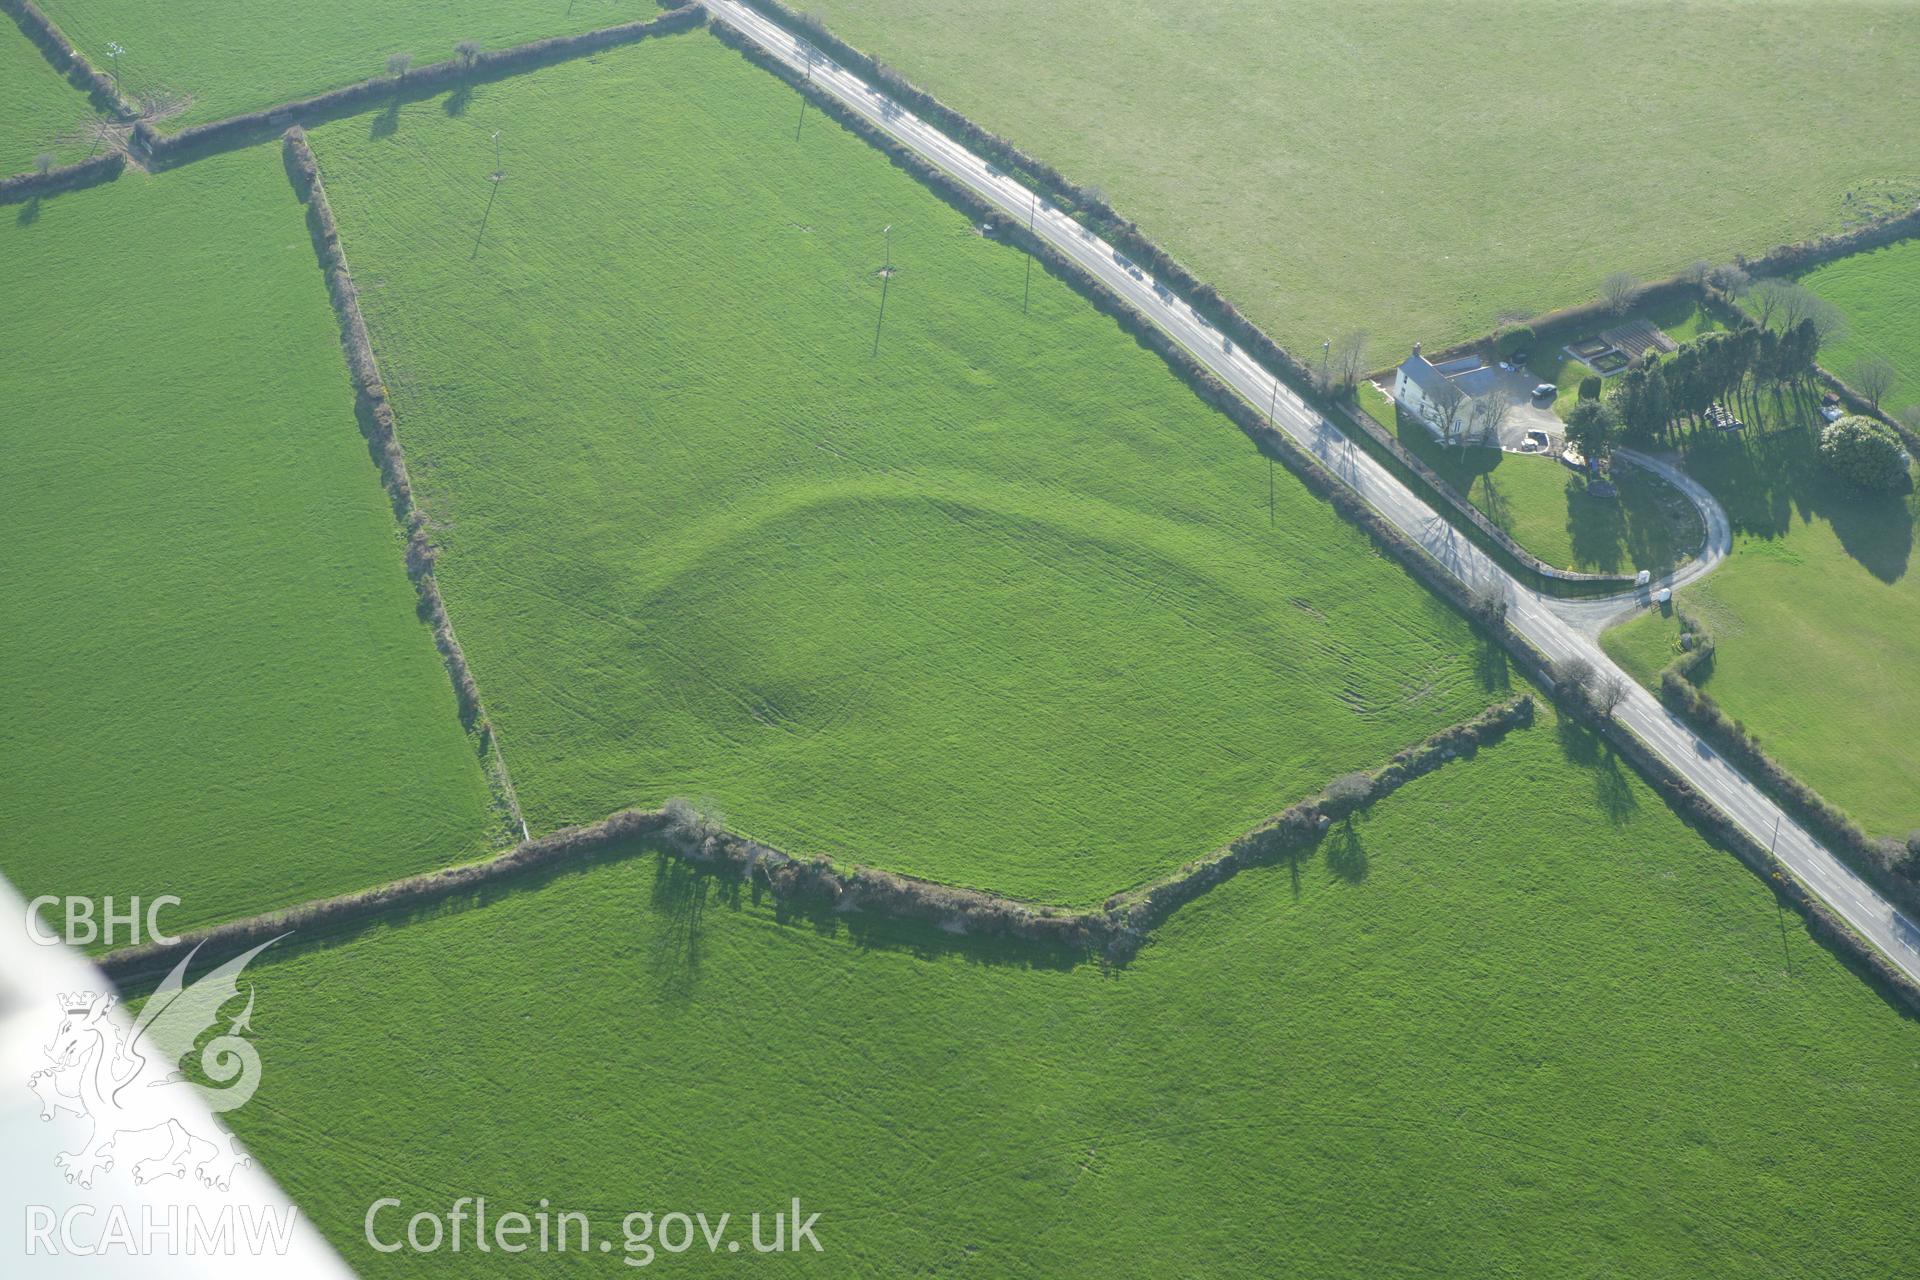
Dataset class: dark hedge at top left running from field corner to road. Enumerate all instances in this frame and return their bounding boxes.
[135,0,707,165]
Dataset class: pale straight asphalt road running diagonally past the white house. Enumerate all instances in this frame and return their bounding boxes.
[708,0,1920,979]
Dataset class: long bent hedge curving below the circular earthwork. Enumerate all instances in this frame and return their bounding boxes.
[100,695,1534,983]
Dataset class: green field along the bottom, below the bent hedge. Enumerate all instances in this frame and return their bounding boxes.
[232,694,1920,1278]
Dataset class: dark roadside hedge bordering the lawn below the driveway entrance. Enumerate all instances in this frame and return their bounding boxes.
[1659,614,1920,915]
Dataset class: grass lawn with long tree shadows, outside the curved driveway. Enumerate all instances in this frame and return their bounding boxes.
[1603,402,1920,835]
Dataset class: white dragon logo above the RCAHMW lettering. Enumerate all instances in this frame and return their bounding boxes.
[27,935,284,1192]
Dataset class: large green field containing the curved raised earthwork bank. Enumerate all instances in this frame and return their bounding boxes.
[313,35,1486,904]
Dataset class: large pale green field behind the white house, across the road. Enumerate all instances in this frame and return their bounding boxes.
[799,0,1920,355]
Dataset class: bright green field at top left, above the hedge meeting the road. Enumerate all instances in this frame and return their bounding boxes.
[40,0,637,130]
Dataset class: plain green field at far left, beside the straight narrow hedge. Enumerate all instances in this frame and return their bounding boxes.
[0,148,497,927]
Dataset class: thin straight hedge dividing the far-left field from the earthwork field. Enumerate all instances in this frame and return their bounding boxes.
[282,125,526,835]
